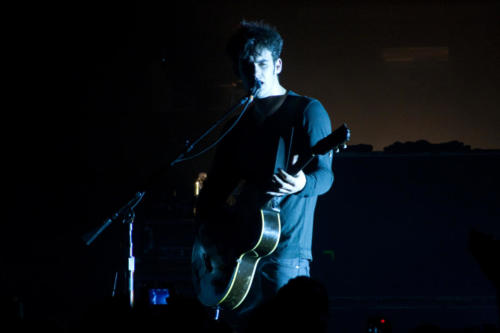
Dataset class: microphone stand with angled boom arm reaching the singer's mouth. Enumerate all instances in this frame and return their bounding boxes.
[82,87,259,307]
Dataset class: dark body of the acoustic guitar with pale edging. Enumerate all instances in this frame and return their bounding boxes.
[192,205,281,309]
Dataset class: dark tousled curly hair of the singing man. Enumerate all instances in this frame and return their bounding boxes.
[226,20,283,76]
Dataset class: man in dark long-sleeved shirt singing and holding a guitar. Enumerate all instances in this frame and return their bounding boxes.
[193,21,333,324]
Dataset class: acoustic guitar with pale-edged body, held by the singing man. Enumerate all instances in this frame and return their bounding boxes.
[192,124,350,309]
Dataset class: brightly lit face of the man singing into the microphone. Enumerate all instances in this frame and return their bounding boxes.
[238,49,282,98]
